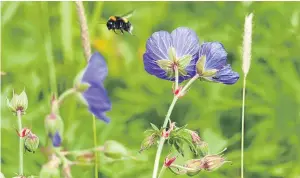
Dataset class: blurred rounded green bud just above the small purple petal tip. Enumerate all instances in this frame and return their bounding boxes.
[45,113,64,137]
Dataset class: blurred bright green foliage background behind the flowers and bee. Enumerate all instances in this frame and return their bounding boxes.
[1,2,300,178]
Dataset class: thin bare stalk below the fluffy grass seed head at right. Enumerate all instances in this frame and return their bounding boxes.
[241,76,246,178]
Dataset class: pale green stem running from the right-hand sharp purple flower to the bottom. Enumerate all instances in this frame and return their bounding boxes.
[152,74,199,178]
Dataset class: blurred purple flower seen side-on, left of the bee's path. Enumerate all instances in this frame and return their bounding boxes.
[81,52,111,122]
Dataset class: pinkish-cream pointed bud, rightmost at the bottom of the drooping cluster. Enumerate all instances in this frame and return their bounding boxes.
[200,155,229,171]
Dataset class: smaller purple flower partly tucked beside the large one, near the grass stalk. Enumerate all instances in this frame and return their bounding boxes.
[196,42,240,85]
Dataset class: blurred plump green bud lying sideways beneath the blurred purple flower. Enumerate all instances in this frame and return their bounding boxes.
[104,140,128,159]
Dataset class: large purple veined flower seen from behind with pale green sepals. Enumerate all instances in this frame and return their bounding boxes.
[143,27,199,82]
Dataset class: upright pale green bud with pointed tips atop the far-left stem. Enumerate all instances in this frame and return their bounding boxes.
[7,90,28,114]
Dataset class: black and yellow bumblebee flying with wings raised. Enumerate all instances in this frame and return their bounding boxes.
[106,11,134,35]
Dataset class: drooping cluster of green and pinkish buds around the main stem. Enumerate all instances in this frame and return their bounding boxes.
[141,122,229,176]
